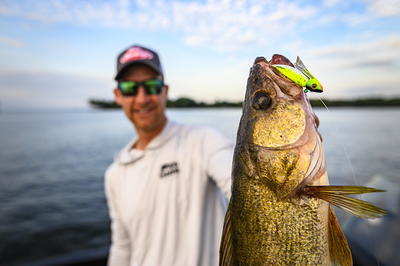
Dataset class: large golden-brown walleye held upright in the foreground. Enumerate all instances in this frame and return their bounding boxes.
[220,55,385,266]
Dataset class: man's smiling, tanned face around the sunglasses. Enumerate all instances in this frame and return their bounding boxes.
[114,65,168,133]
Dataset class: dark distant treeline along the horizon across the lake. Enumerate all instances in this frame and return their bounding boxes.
[89,97,400,109]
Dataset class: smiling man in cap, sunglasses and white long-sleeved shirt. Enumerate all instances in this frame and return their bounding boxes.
[105,45,233,266]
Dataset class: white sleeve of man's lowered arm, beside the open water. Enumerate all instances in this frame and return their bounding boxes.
[105,166,131,266]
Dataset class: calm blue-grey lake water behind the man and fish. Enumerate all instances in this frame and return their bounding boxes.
[0,108,400,265]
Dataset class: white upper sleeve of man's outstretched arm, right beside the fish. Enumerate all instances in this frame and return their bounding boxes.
[203,129,234,200]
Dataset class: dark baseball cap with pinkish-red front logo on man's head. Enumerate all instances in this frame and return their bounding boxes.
[115,45,164,80]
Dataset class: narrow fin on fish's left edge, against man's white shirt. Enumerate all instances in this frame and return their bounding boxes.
[219,201,233,266]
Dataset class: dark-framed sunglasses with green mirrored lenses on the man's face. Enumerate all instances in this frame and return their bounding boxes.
[118,79,164,96]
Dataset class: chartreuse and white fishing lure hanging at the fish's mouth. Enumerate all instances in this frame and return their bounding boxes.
[273,57,323,92]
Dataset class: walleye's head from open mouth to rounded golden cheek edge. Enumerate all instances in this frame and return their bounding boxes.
[243,55,314,148]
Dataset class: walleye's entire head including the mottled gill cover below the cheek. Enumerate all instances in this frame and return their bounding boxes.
[237,55,318,197]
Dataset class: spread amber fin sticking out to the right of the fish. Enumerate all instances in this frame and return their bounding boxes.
[304,186,386,218]
